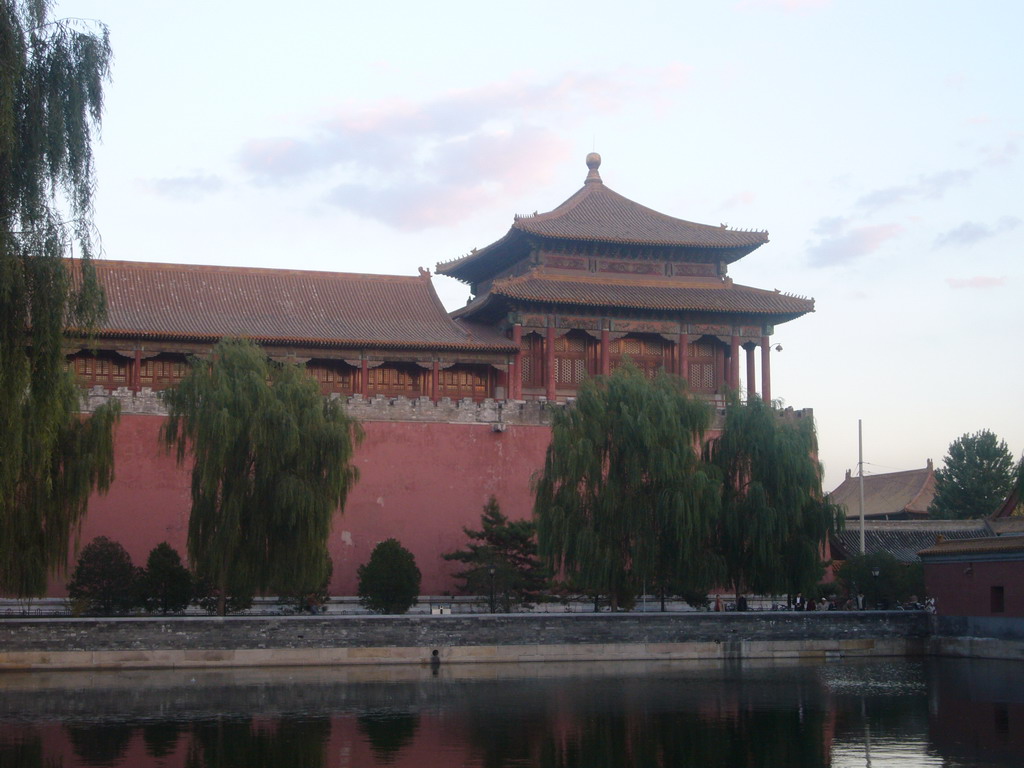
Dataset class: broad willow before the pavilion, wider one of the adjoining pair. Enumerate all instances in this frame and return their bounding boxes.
[534,366,719,609]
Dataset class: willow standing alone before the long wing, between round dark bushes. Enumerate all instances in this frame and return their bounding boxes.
[161,339,361,614]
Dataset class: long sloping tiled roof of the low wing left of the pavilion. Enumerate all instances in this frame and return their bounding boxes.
[74,260,511,351]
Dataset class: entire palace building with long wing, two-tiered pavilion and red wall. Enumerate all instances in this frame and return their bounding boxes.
[64,155,814,594]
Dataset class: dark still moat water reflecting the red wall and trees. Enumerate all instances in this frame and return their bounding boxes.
[0,659,1024,768]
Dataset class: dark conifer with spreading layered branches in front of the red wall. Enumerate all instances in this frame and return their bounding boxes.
[442,497,548,613]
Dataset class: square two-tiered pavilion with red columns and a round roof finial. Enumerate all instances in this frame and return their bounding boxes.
[437,153,814,401]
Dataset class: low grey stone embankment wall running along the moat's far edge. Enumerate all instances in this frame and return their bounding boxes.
[0,611,930,670]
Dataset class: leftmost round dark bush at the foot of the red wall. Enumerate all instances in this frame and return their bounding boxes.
[68,536,140,615]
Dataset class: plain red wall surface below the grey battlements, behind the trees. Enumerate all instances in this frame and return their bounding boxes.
[66,414,550,596]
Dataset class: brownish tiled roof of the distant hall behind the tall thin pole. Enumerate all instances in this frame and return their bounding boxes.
[830,459,935,523]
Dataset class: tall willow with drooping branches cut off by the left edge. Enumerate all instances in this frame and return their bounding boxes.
[0,0,117,597]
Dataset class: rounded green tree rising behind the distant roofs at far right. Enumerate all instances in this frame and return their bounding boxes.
[928,429,1015,520]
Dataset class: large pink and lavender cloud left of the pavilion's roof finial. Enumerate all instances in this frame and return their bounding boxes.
[239,63,690,229]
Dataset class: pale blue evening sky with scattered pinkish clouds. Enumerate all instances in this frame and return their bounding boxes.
[53,0,1024,490]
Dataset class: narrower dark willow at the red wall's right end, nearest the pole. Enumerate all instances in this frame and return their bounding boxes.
[707,398,842,601]
